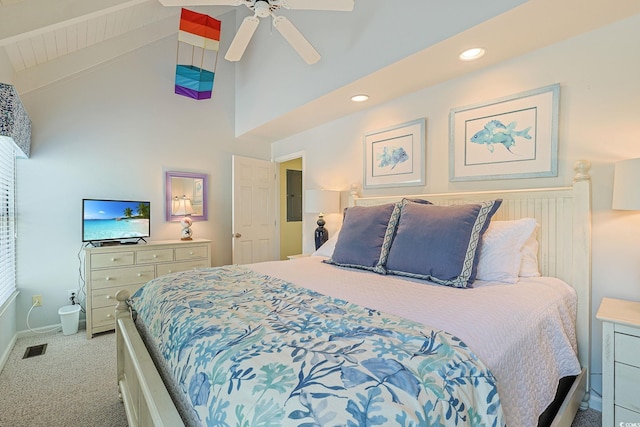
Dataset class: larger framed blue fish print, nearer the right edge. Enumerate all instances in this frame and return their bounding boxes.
[449,84,560,181]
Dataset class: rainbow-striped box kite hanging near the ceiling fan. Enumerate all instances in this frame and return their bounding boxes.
[175,9,220,99]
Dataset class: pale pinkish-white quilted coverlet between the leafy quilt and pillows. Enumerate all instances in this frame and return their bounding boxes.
[247,256,580,427]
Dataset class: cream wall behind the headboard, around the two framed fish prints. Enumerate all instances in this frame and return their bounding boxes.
[272,16,640,408]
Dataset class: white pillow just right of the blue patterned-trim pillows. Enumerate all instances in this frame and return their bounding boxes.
[476,218,537,283]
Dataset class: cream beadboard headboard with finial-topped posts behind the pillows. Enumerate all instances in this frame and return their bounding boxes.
[349,161,591,399]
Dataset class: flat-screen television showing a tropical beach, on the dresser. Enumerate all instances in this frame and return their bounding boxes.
[82,199,151,246]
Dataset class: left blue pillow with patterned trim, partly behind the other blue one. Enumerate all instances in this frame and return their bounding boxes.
[324,203,396,274]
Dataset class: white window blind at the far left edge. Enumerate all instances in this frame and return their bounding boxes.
[0,137,16,306]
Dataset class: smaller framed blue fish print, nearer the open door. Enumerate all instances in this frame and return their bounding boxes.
[363,118,426,188]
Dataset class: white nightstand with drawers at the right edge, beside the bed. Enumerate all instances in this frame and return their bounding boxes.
[596,298,640,426]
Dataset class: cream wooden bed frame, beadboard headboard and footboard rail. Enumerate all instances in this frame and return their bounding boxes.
[116,161,591,427]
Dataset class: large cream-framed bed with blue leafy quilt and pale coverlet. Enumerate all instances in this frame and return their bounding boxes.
[116,162,591,426]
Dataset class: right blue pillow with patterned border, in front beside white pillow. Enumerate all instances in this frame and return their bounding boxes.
[386,199,502,288]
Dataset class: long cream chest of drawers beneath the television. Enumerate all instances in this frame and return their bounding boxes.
[85,239,211,338]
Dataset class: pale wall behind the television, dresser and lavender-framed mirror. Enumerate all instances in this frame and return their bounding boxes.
[11,34,270,330]
